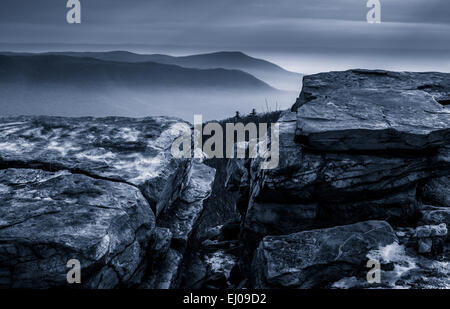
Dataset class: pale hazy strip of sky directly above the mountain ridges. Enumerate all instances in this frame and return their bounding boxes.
[0,42,450,74]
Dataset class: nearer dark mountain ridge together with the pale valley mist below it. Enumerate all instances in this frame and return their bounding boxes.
[0,54,298,121]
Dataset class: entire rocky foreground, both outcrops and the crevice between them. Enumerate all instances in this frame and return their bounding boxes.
[0,70,450,288]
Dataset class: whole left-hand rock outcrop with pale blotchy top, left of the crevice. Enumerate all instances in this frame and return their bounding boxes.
[0,117,214,288]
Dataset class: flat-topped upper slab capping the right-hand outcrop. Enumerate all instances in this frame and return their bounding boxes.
[294,70,450,151]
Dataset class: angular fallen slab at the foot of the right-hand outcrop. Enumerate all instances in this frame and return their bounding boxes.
[252,221,397,288]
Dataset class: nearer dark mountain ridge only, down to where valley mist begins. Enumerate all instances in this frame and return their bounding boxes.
[0,55,274,91]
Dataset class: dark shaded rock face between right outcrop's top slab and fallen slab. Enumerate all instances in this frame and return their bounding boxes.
[243,113,450,248]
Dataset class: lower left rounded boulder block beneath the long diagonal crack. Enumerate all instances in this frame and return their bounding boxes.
[0,169,155,288]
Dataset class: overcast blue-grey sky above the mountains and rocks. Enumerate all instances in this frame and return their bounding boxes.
[0,0,450,73]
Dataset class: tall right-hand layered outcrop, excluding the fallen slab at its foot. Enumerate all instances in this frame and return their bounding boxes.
[234,70,450,287]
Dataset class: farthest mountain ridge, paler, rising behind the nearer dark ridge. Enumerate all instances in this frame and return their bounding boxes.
[1,51,302,91]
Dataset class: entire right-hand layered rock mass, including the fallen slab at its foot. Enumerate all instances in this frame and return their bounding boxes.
[228,70,450,288]
